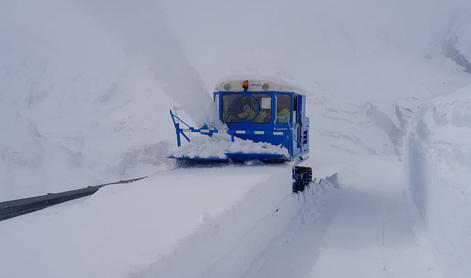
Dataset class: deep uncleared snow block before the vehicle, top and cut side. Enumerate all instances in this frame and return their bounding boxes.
[0,165,340,278]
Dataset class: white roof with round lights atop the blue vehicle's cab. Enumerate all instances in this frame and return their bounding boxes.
[214,80,304,94]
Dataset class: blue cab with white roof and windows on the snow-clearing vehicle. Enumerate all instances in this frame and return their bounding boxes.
[214,80,309,159]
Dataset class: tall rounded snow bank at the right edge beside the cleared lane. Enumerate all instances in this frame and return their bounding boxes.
[407,86,471,277]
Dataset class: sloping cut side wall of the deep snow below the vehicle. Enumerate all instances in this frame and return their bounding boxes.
[136,167,337,278]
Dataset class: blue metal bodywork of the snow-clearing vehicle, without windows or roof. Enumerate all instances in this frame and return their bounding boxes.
[170,88,309,162]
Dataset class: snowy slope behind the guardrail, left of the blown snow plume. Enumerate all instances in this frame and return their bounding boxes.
[0,0,177,200]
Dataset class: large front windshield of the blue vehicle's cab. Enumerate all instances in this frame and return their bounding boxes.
[222,93,272,124]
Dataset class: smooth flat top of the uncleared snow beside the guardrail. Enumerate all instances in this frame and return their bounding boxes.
[0,168,276,278]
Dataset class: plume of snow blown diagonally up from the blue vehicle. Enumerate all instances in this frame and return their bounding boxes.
[78,0,212,124]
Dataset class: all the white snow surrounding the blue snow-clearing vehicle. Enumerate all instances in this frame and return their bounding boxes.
[0,0,471,278]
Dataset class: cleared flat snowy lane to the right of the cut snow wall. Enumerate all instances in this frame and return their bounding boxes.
[244,156,442,278]
